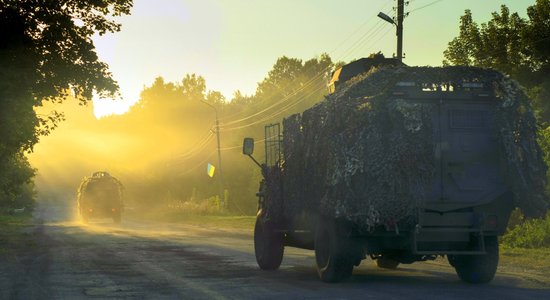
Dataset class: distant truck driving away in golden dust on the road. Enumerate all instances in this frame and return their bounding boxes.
[77,172,124,223]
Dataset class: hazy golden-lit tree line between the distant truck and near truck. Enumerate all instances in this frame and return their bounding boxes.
[29,54,334,214]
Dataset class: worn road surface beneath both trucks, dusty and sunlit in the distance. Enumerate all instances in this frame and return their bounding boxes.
[0,206,550,300]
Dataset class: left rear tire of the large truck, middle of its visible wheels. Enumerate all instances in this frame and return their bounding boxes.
[315,219,355,282]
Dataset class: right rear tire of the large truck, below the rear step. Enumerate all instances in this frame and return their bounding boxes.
[448,236,499,283]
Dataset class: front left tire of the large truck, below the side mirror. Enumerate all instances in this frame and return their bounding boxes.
[254,215,285,270]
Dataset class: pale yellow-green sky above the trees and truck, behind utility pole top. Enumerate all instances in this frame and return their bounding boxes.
[94,0,535,117]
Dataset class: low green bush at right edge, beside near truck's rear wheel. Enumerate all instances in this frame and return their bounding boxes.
[501,213,550,248]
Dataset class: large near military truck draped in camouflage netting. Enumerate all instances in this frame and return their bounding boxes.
[243,59,548,283]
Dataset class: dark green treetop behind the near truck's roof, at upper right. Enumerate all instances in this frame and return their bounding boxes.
[443,0,550,123]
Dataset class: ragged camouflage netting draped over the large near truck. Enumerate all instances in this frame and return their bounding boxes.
[267,67,549,229]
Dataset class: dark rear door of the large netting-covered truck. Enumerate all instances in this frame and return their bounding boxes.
[436,99,505,206]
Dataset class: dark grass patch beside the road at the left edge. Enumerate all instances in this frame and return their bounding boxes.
[0,212,35,255]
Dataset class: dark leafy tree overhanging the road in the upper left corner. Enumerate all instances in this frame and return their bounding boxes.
[0,0,132,204]
